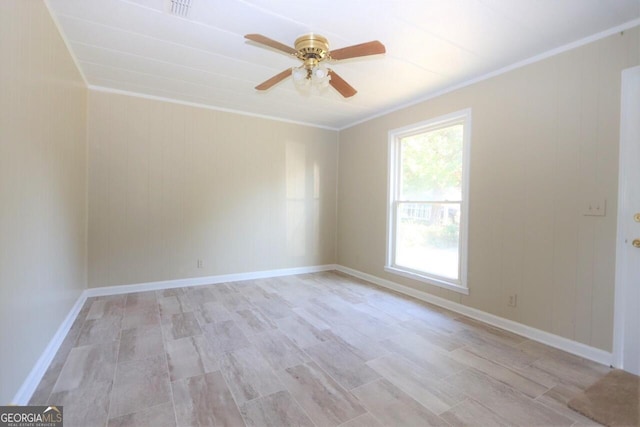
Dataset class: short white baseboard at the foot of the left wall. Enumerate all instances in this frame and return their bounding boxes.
[12,291,87,405]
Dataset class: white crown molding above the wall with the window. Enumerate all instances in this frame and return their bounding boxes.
[338,18,640,131]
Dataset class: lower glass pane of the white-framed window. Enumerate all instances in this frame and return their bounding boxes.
[396,203,460,280]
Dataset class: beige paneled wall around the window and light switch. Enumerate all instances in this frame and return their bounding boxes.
[338,27,640,351]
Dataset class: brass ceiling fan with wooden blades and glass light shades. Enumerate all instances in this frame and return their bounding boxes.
[244,33,386,98]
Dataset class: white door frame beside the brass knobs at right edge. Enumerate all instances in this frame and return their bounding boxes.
[612,66,640,368]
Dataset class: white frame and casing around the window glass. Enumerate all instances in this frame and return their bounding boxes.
[384,108,471,295]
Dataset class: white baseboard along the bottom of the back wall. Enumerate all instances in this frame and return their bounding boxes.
[85,264,337,297]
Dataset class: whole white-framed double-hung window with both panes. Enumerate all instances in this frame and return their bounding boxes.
[385,109,471,294]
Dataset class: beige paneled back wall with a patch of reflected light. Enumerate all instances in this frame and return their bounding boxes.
[88,91,337,287]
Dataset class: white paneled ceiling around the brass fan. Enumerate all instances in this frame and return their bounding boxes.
[48,0,640,129]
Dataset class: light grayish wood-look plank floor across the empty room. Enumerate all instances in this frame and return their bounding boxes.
[30,272,608,427]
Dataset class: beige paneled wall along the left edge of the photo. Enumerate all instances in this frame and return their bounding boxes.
[0,0,86,404]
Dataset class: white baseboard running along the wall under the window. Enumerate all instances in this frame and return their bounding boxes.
[336,265,613,366]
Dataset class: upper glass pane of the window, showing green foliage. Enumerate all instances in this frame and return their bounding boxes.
[400,124,463,201]
